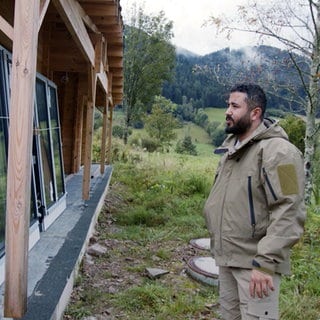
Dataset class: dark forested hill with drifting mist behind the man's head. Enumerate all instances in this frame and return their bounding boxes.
[162,46,308,113]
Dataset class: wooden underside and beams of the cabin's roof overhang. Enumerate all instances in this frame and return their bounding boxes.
[0,0,123,104]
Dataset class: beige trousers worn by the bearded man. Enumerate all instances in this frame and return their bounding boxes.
[219,267,281,320]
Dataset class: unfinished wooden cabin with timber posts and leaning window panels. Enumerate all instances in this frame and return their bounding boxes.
[0,0,123,318]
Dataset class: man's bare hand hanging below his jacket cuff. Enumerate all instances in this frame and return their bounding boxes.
[250,269,274,298]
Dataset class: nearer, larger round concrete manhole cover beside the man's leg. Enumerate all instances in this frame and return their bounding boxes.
[187,257,219,286]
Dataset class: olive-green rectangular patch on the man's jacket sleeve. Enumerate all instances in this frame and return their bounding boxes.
[277,164,299,196]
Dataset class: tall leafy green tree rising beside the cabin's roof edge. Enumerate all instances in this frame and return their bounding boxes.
[123,5,175,143]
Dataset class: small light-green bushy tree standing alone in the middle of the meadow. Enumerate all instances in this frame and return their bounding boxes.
[145,97,178,148]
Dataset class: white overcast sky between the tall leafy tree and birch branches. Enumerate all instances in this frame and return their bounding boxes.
[120,0,262,55]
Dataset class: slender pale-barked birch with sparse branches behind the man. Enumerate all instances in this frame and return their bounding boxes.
[210,0,320,204]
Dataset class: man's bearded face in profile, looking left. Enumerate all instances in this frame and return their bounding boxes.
[225,92,252,135]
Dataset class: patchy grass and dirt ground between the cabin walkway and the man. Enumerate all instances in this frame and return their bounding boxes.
[64,151,218,320]
